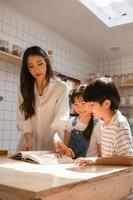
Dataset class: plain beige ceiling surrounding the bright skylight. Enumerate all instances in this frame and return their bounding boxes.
[1,0,133,59]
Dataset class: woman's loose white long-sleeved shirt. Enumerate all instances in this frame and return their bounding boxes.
[17,78,69,150]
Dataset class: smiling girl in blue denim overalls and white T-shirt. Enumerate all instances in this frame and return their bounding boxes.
[53,86,101,158]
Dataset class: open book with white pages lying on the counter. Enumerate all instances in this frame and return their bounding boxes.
[10,151,73,164]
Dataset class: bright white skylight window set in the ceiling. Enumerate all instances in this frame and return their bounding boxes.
[79,0,133,27]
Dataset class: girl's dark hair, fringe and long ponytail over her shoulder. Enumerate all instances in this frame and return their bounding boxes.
[69,85,94,141]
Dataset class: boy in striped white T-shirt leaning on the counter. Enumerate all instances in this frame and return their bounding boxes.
[76,77,133,165]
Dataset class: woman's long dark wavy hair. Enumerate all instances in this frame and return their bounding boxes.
[20,46,53,119]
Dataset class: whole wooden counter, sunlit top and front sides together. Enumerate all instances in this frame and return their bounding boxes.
[0,157,133,200]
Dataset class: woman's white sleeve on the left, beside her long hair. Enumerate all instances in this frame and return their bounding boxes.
[17,94,32,133]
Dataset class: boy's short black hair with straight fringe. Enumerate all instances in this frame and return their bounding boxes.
[83,77,120,111]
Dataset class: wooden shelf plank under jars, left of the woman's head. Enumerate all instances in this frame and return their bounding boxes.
[0,51,22,65]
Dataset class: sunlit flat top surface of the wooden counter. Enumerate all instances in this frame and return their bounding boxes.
[0,156,133,193]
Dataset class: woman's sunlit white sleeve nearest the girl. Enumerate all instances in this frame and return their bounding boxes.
[51,82,69,133]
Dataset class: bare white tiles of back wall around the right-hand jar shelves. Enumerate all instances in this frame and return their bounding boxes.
[97,56,133,132]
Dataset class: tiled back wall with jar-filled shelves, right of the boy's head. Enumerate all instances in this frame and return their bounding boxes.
[97,56,133,132]
